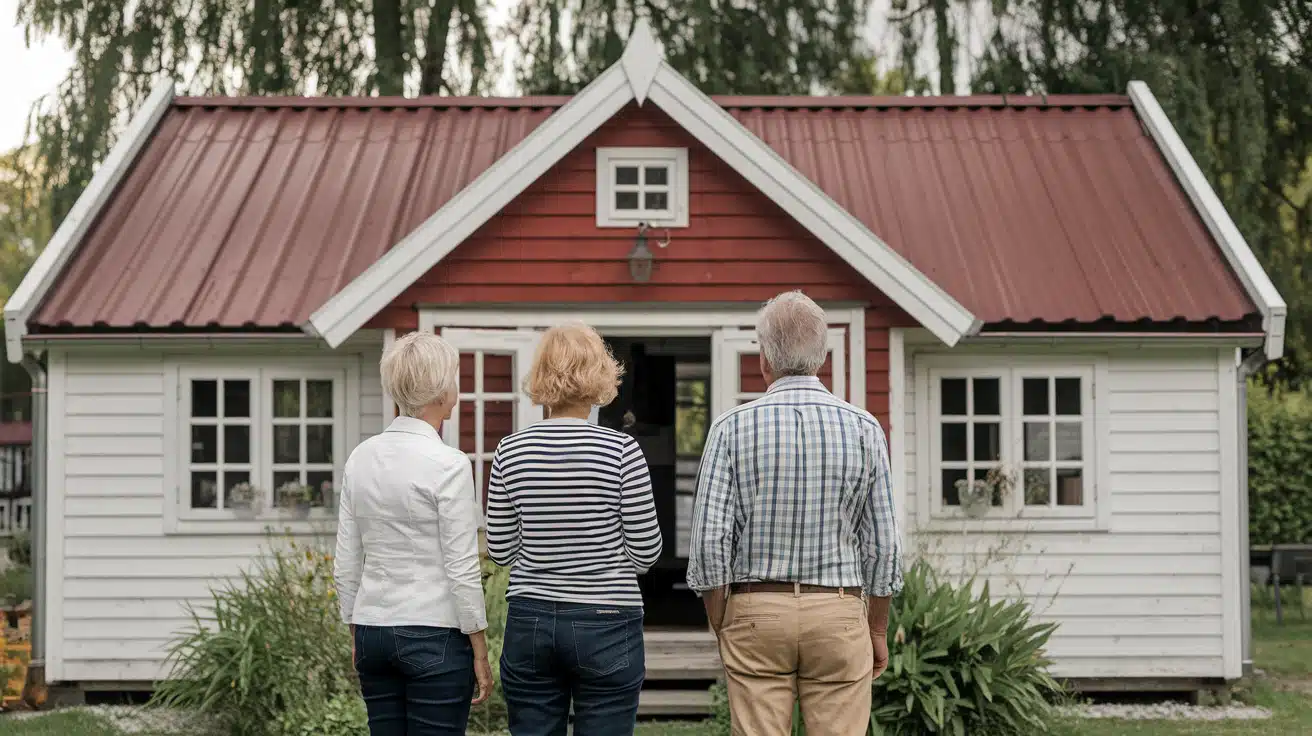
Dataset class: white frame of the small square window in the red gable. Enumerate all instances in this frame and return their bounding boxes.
[597,147,689,227]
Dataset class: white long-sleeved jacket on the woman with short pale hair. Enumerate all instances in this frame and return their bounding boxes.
[333,417,487,634]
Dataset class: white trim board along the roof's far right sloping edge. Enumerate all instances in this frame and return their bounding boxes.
[1130,81,1288,361]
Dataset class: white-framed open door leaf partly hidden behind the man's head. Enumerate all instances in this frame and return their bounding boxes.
[711,327,848,416]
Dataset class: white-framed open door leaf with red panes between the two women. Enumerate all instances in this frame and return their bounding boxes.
[442,327,542,522]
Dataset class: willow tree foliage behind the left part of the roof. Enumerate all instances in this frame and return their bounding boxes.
[18,0,491,222]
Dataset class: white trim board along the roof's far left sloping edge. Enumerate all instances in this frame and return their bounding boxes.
[4,79,173,363]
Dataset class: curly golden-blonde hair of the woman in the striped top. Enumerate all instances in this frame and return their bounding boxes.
[523,323,625,409]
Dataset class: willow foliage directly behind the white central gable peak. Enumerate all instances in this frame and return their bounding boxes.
[510,0,869,94]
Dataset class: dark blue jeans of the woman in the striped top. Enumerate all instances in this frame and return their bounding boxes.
[501,597,647,736]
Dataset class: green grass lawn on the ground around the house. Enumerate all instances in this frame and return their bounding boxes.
[0,606,1312,736]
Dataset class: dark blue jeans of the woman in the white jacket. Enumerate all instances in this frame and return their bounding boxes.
[356,626,474,736]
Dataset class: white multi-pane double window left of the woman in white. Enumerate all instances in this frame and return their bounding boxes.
[178,367,345,518]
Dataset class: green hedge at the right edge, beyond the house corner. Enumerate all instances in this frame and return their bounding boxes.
[1248,386,1312,544]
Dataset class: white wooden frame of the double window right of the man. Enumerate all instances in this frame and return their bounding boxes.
[916,354,1111,531]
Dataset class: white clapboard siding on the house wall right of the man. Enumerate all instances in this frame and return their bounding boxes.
[899,349,1225,678]
